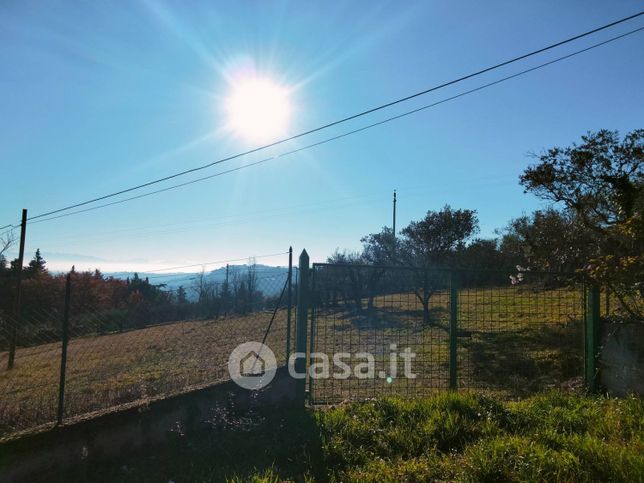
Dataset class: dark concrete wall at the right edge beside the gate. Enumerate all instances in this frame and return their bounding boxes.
[599,323,644,396]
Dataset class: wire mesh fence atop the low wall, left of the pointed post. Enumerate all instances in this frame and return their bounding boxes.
[0,260,297,438]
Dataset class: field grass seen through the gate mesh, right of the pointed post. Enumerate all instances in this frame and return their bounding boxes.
[313,286,583,403]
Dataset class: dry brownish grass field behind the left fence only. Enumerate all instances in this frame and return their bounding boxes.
[0,311,286,437]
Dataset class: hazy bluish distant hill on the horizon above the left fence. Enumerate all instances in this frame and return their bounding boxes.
[103,264,295,298]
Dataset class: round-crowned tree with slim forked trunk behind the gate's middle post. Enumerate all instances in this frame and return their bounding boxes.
[396,205,478,328]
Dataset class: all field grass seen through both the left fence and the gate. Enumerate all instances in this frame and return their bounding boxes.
[0,287,583,438]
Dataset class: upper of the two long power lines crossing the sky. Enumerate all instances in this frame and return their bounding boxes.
[13,11,644,224]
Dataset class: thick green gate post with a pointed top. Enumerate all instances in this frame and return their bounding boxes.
[295,250,310,405]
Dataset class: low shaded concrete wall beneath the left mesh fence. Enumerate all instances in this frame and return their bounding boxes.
[0,368,295,482]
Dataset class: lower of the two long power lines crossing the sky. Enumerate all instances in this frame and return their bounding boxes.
[25,27,644,228]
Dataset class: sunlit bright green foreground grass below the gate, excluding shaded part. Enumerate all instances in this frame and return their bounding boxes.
[318,392,644,481]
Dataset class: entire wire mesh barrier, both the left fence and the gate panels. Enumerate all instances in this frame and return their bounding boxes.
[0,258,585,437]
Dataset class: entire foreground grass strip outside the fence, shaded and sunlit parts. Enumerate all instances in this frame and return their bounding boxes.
[52,392,644,482]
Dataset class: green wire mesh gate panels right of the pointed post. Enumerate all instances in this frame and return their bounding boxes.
[309,264,585,403]
